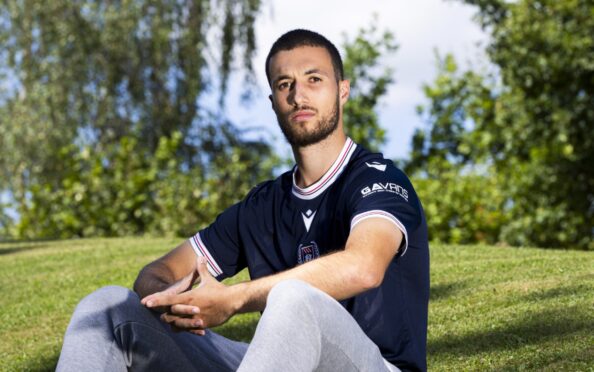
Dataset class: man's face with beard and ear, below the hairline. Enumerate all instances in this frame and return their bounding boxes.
[269,46,348,147]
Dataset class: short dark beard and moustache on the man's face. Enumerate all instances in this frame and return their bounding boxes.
[276,94,339,147]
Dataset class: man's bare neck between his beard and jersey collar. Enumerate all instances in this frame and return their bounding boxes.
[293,128,346,188]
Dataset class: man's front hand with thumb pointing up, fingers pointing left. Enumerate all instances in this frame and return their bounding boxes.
[141,257,238,335]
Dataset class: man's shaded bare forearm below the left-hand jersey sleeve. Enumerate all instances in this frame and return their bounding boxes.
[134,240,198,298]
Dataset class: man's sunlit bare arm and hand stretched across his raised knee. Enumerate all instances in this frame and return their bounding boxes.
[142,218,402,334]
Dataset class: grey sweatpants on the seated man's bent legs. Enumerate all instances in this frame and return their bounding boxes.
[57,280,398,372]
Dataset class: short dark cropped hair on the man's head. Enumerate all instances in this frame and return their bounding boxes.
[266,29,344,84]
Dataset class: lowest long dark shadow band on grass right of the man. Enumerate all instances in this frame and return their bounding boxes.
[427,306,592,357]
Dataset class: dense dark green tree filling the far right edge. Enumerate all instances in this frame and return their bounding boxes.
[479,0,594,249]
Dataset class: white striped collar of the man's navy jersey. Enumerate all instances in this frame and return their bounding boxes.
[293,137,357,200]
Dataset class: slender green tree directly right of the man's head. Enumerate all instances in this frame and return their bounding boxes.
[343,22,397,151]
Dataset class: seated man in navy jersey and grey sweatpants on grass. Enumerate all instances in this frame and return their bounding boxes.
[58,30,429,371]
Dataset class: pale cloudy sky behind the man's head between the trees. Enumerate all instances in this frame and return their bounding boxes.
[222,0,488,159]
